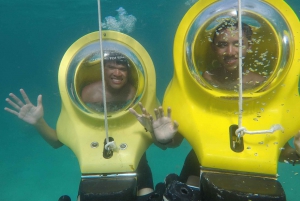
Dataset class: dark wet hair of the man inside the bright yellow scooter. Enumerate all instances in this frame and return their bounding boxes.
[213,18,253,41]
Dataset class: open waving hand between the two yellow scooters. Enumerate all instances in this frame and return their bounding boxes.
[129,103,183,149]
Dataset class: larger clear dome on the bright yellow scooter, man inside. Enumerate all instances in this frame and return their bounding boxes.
[185,0,293,94]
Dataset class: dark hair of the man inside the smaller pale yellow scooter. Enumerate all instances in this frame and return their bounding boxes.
[103,50,130,69]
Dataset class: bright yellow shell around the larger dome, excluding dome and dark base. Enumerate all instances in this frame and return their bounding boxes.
[163,0,300,175]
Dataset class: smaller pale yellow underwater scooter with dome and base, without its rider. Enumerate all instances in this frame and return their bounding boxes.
[57,31,158,200]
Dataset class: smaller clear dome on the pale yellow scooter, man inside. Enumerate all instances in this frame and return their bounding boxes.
[67,40,145,113]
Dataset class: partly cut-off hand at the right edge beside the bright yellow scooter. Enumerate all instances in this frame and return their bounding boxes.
[279,131,300,164]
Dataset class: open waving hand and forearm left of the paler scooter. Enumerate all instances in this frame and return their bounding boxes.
[4,89,63,148]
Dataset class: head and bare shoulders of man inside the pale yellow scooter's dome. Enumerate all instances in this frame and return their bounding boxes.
[81,50,136,112]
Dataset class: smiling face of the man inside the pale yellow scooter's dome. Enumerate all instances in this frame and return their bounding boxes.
[104,61,128,89]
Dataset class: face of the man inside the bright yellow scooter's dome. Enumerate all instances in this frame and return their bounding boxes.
[212,27,250,71]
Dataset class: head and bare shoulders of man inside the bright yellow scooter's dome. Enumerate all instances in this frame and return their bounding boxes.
[203,18,265,90]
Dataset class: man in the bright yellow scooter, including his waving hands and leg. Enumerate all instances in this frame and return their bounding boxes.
[129,19,300,186]
